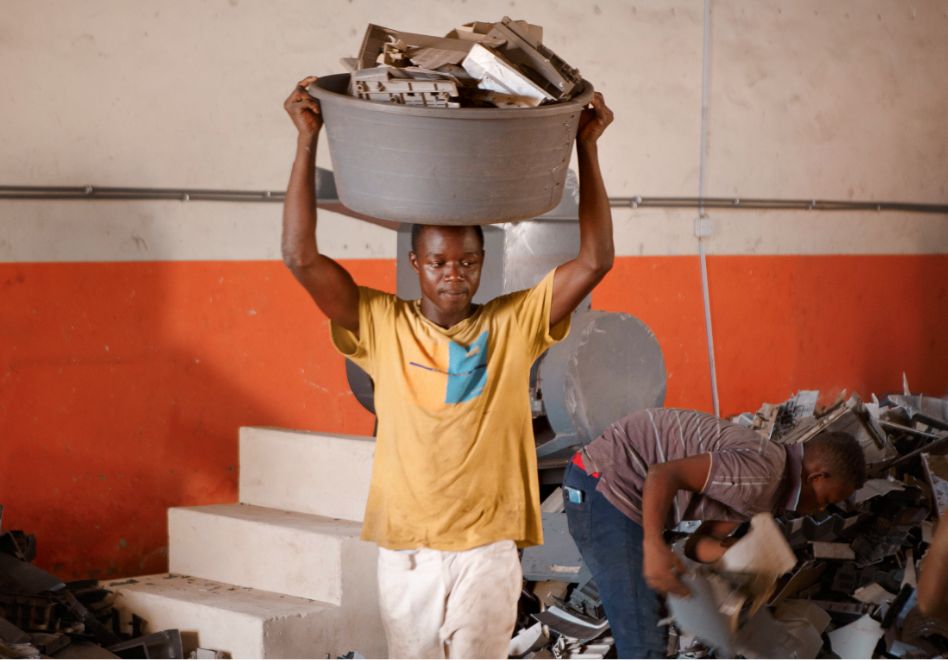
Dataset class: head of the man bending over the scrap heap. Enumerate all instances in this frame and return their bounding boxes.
[797,431,866,513]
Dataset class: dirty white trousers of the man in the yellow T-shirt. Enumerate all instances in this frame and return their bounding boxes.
[378,541,523,658]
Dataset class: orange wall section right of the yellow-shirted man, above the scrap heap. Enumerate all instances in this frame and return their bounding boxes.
[593,255,948,415]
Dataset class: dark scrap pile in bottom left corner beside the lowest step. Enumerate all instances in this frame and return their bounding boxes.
[0,506,184,658]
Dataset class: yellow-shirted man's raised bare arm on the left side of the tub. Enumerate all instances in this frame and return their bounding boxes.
[282,77,359,333]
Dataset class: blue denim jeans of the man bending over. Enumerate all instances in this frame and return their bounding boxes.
[563,463,665,658]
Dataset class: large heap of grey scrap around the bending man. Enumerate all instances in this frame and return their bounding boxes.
[510,386,948,658]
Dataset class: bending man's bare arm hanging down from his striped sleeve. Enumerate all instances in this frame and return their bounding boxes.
[642,454,711,596]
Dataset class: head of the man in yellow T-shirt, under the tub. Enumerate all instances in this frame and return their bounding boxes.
[408,225,484,326]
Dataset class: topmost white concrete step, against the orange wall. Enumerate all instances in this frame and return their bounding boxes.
[239,427,375,521]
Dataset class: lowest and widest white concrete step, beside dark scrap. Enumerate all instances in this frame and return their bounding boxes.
[105,574,386,658]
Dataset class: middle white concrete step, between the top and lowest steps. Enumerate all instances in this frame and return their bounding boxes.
[168,504,378,609]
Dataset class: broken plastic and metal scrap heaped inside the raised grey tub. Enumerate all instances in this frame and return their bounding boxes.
[342,16,582,108]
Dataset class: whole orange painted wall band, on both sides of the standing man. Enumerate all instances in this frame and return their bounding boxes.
[0,255,948,579]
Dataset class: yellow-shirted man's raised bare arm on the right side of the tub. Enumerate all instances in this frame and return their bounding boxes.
[550,92,615,327]
